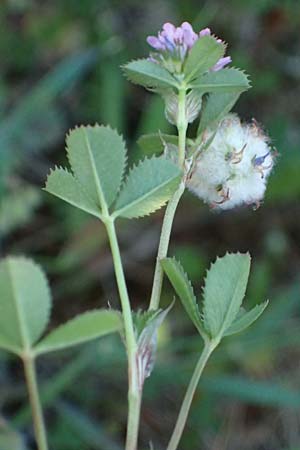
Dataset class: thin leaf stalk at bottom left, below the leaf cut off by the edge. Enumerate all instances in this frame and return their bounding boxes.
[23,352,48,450]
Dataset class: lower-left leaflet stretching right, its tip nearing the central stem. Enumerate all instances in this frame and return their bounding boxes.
[35,309,122,355]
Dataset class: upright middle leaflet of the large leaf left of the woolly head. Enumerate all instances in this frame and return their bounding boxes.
[67,125,126,208]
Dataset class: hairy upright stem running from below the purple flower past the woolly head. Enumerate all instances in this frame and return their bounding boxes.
[149,87,188,309]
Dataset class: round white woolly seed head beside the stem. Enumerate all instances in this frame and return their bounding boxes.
[188,114,274,209]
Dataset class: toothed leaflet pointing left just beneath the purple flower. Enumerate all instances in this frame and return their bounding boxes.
[123,59,177,89]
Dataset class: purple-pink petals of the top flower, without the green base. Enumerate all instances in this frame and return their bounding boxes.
[147,22,231,71]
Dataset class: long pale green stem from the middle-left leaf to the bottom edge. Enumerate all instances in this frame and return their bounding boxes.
[105,217,142,450]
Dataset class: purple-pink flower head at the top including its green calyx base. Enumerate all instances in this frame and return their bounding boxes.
[147,22,231,73]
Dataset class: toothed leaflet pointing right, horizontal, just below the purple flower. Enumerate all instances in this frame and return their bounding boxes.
[191,67,250,93]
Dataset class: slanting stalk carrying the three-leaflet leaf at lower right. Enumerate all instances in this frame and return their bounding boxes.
[167,342,218,450]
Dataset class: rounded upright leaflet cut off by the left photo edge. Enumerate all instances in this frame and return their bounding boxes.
[0,257,51,353]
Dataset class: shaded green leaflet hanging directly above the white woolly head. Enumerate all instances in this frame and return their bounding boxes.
[197,92,240,135]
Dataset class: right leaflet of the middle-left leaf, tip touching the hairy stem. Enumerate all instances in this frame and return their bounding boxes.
[113,157,181,219]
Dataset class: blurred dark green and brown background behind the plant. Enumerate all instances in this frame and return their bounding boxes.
[0,0,300,450]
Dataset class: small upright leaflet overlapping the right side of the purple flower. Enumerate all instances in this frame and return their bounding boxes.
[184,36,225,81]
